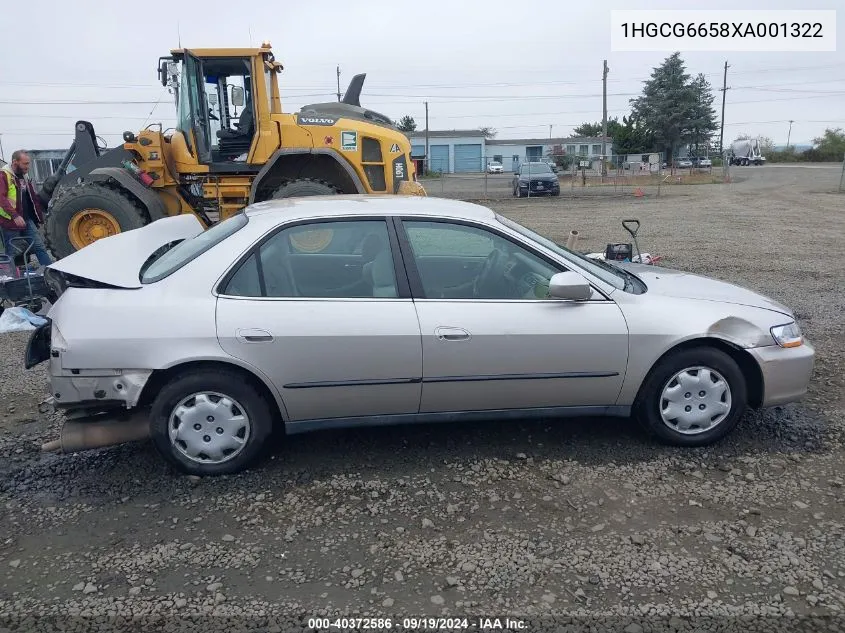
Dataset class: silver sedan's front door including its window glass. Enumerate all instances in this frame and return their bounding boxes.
[402,219,628,413]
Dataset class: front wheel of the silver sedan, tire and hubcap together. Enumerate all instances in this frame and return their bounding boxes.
[634,347,748,446]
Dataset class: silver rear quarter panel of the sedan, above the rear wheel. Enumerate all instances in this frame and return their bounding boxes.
[48,215,286,416]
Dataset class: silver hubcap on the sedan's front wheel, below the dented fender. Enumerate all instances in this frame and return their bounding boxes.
[660,366,731,435]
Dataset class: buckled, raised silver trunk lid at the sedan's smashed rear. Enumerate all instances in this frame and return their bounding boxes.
[47,214,205,288]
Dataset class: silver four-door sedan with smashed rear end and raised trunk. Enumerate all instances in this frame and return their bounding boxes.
[31,195,814,475]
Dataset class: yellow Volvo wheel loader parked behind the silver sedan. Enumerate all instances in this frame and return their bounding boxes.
[41,43,425,258]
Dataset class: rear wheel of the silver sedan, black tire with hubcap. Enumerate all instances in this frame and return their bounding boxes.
[150,369,274,476]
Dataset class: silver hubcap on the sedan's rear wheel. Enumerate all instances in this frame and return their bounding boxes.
[167,391,251,464]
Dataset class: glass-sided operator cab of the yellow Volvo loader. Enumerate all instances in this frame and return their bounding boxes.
[170,49,277,173]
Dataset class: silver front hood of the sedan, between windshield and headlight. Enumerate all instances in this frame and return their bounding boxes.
[611,262,794,318]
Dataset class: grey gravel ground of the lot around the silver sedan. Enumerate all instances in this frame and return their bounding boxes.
[0,166,845,633]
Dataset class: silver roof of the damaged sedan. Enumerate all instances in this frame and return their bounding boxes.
[244,194,495,222]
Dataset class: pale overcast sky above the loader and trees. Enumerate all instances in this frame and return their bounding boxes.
[0,0,845,159]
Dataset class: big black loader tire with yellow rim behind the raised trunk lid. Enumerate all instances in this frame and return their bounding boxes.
[45,183,149,259]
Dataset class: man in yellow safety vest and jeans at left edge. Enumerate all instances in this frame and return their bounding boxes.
[0,150,53,266]
